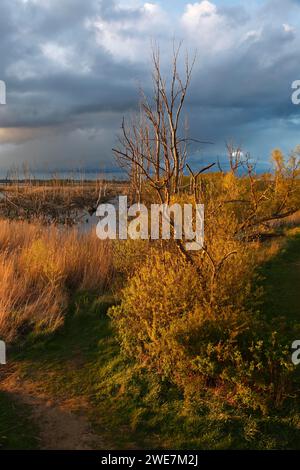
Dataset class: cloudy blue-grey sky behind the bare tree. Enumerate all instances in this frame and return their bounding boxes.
[0,0,300,173]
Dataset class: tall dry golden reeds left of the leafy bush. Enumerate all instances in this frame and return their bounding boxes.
[0,220,112,341]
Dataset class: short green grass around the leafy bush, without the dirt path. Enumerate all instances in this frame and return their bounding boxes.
[0,235,300,449]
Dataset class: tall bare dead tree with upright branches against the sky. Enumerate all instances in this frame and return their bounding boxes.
[113,44,195,203]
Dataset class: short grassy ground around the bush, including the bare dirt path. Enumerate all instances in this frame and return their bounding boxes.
[0,233,300,449]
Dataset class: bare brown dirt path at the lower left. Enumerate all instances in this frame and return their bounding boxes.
[0,372,107,450]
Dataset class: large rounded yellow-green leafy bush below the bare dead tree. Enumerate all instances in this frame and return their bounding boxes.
[109,251,292,410]
